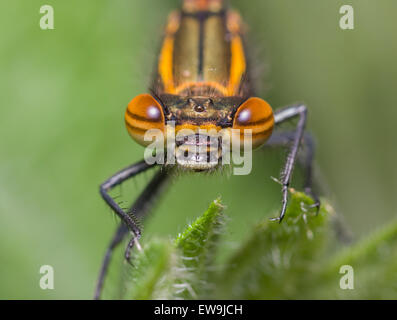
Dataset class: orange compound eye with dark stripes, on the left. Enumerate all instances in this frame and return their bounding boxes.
[125,94,165,146]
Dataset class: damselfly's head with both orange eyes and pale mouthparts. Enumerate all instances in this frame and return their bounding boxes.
[125,94,274,171]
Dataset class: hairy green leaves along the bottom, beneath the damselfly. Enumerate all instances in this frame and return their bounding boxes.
[119,189,397,299]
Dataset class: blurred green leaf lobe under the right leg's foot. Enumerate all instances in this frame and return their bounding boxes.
[214,193,329,299]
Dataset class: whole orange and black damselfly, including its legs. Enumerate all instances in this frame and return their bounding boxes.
[95,0,319,298]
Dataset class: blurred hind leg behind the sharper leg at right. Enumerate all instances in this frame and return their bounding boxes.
[265,131,320,213]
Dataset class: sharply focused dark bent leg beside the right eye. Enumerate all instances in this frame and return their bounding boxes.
[272,105,318,222]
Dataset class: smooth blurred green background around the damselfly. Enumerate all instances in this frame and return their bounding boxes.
[0,0,397,299]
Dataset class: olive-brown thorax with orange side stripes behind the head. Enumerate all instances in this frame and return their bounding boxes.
[155,1,250,96]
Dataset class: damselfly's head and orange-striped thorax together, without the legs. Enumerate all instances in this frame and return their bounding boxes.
[125,1,274,170]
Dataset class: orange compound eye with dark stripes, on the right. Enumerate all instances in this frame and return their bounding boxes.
[233,98,274,148]
